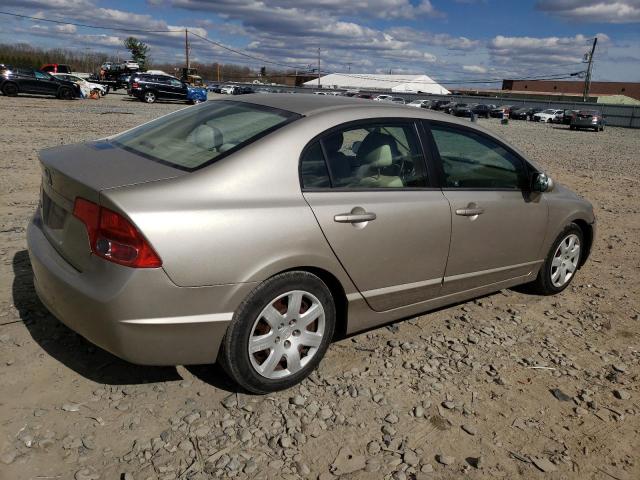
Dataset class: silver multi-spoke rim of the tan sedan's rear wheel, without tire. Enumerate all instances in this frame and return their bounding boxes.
[247,290,326,379]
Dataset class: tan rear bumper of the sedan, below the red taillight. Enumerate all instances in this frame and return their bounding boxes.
[27,213,255,365]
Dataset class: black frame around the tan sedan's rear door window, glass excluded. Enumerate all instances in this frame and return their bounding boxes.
[298,117,440,193]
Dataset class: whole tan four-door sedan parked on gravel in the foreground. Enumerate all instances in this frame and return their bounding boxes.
[28,94,595,393]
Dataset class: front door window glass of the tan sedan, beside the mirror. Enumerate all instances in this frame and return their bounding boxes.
[431,125,526,189]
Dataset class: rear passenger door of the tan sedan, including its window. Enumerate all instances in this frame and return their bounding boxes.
[300,119,451,311]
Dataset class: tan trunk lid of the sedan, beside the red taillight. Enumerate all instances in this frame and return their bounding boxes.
[40,141,187,271]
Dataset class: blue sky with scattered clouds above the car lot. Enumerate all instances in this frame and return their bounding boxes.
[0,0,640,88]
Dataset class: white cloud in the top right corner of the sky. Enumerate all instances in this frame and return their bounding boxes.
[536,0,640,23]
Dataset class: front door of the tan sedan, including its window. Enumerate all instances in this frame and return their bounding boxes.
[429,121,548,294]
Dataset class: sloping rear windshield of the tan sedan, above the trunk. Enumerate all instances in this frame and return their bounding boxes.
[112,100,300,171]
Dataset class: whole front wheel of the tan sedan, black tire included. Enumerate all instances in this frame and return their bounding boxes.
[530,223,585,295]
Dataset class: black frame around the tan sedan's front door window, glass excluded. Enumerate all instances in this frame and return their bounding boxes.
[422,120,539,193]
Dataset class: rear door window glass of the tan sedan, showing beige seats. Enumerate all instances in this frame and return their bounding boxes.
[301,123,427,189]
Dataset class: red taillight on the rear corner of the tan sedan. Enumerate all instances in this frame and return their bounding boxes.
[73,198,162,268]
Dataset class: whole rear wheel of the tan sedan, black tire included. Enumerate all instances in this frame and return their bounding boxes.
[218,271,336,394]
